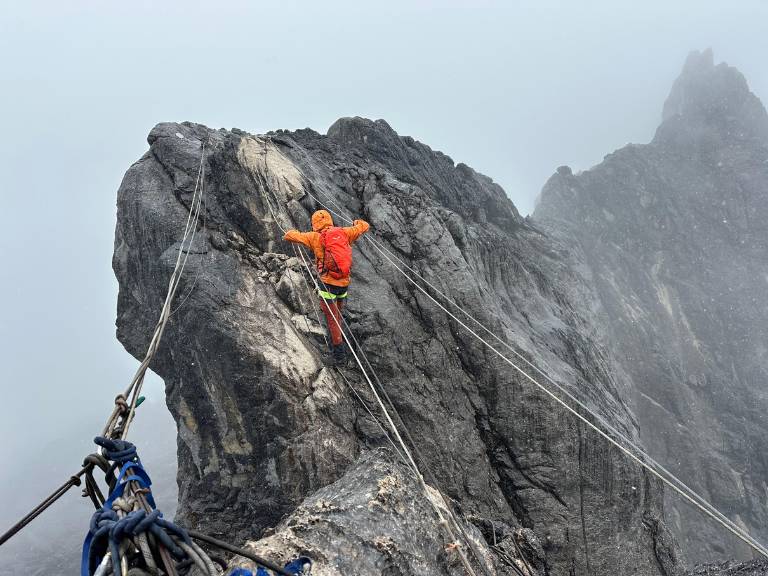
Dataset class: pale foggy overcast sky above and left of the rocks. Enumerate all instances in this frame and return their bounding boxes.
[0,0,768,548]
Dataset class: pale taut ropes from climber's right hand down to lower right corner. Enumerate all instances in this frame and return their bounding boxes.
[292,173,768,558]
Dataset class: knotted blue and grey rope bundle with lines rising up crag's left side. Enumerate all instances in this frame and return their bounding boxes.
[0,142,312,576]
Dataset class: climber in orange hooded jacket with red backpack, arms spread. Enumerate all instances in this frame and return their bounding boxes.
[283,210,370,365]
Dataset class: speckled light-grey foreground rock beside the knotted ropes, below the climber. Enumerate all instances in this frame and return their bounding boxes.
[234,450,500,576]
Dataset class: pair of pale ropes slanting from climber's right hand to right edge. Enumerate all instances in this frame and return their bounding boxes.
[296,181,768,558]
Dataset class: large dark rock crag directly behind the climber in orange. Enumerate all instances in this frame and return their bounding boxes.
[114,118,677,575]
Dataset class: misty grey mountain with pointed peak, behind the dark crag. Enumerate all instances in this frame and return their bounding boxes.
[535,51,768,561]
